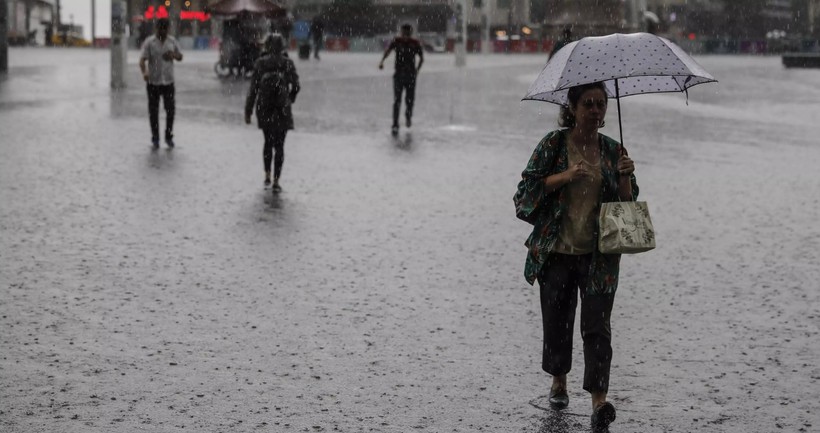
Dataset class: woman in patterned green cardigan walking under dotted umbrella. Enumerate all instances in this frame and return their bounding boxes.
[514,83,638,428]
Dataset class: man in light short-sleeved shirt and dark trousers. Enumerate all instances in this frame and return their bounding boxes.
[140,18,182,149]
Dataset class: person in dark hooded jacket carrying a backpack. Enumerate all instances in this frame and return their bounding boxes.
[245,34,299,193]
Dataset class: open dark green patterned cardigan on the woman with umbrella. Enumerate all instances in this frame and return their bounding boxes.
[513,129,638,294]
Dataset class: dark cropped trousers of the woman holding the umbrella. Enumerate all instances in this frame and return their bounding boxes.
[538,254,614,392]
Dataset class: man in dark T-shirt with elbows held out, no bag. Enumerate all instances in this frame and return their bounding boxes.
[379,24,424,136]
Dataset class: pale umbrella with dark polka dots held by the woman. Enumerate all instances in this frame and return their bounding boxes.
[522,33,717,142]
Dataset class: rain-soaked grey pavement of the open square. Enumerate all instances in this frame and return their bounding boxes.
[0,49,820,433]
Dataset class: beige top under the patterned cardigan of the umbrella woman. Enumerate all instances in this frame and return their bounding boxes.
[553,143,603,255]
